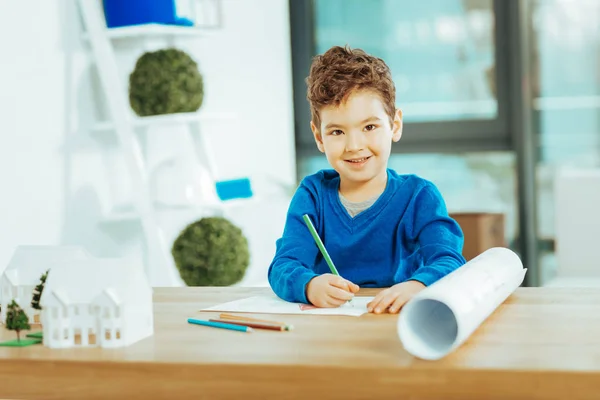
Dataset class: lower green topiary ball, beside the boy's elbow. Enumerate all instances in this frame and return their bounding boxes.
[171,217,250,286]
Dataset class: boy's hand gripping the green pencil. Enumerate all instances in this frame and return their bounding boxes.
[306,274,359,308]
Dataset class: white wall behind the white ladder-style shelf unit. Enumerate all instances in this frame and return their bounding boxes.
[0,0,295,284]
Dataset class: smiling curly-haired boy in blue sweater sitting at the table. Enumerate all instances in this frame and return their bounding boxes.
[268,46,465,314]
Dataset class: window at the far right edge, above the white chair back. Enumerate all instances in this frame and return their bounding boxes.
[529,0,600,284]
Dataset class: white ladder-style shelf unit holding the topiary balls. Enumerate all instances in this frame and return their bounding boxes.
[77,0,245,286]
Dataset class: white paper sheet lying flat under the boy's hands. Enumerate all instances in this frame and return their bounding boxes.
[202,294,373,317]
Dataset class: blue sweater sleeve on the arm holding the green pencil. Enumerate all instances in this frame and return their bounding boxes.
[268,183,319,303]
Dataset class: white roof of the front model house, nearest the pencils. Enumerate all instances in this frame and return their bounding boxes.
[41,258,151,306]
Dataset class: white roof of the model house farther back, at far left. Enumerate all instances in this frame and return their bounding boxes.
[4,246,90,286]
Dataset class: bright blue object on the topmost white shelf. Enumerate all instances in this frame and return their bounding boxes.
[103,0,194,28]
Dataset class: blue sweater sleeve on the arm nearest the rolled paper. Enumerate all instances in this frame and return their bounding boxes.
[408,183,466,286]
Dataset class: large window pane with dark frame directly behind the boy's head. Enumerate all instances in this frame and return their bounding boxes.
[290,0,510,158]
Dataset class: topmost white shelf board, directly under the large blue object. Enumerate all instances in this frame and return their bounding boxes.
[83,24,213,39]
